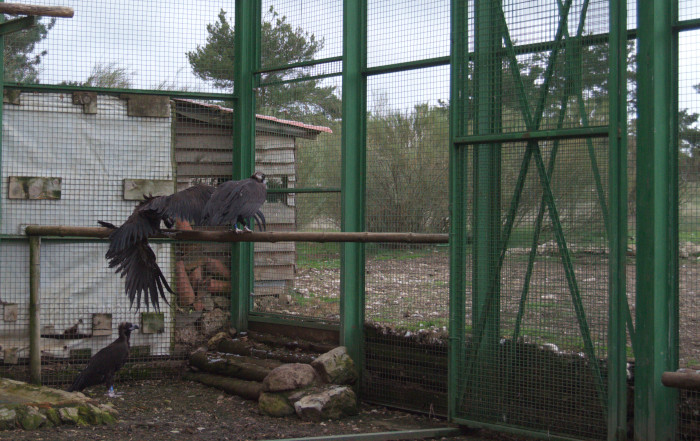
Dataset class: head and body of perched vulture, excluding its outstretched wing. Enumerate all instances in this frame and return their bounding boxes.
[202,172,267,233]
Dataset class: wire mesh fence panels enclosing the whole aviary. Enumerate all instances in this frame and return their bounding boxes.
[0,0,700,439]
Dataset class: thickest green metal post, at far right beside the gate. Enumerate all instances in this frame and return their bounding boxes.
[634,0,678,441]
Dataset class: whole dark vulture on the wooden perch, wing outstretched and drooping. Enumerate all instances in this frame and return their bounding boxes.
[98,172,267,310]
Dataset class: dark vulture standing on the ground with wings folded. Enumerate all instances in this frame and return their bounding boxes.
[67,322,139,397]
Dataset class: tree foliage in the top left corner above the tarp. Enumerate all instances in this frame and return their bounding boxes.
[4,17,56,83]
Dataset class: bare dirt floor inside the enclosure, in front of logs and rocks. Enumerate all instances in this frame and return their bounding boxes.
[0,380,516,441]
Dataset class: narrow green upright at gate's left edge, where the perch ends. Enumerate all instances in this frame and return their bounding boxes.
[447,0,469,420]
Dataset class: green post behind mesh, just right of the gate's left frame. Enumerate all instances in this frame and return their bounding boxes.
[470,0,502,408]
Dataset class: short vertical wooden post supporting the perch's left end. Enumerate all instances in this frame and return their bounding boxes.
[29,236,41,384]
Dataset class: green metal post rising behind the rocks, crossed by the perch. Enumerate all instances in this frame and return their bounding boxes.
[340,0,367,376]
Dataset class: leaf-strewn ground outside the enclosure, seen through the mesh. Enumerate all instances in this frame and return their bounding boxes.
[256,248,700,368]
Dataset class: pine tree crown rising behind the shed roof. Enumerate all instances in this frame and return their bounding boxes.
[187,7,341,118]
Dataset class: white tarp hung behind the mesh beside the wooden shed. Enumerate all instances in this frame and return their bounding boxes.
[0,93,173,357]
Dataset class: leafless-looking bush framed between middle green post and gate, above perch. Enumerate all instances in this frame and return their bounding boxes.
[367,104,449,232]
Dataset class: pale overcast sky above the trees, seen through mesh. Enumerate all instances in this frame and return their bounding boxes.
[23,0,700,117]
